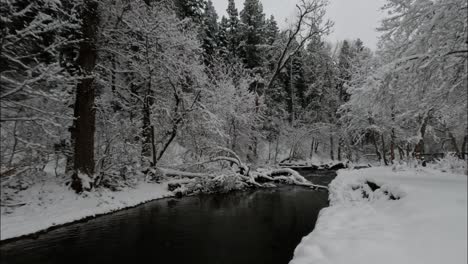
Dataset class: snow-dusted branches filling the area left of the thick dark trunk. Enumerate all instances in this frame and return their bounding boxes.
[0,0,79,182]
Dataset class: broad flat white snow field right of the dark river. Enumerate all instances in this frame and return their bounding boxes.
[290,167,467,264]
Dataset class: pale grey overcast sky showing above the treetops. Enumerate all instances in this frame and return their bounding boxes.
[212,0,385,49]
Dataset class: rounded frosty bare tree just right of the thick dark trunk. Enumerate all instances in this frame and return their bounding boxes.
[96,1,206,172]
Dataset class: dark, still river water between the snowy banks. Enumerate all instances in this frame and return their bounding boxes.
[0,172,334,264]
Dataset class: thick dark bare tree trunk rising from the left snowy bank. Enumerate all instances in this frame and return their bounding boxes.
[71,0,99,193]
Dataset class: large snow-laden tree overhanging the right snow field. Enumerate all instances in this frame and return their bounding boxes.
[340,0,468,163]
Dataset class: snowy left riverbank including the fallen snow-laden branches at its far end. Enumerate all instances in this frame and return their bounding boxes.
[0,164,320,240]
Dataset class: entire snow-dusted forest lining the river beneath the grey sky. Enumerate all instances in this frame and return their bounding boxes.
[0,0,468,192]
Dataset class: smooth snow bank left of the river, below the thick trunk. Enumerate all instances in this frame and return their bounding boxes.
[0,179,173,240]
